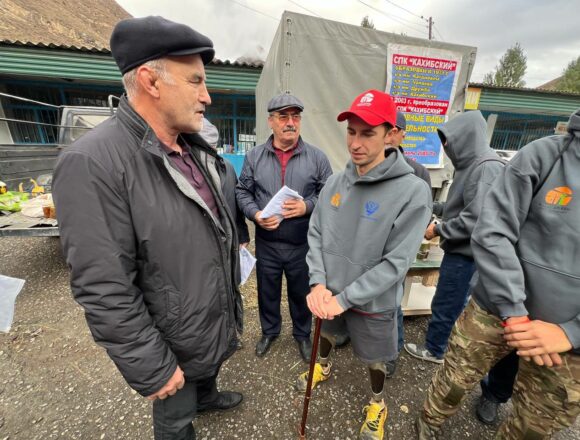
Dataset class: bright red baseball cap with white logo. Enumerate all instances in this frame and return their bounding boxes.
[336,89,397,127]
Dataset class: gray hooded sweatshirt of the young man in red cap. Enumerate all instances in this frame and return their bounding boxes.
[306,150,432,313]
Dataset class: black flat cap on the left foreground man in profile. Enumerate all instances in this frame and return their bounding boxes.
[110,16,215,74]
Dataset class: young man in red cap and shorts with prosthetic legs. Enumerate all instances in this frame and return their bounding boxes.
[296,90,432,439]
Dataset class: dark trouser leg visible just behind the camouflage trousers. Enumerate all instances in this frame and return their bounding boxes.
[481,350,519,403]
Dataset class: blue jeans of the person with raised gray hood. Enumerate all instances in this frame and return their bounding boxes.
[425,253,475,358]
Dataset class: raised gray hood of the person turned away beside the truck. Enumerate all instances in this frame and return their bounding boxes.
[437,111,489,170]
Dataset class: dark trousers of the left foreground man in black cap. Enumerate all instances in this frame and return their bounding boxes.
[153,374,218,440]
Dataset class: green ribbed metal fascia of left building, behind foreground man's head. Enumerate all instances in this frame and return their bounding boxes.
[0,45,261,94]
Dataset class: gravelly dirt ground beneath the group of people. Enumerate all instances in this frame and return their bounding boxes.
[0,237,580,440]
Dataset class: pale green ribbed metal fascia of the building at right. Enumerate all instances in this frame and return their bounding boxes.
[470,83,580,116]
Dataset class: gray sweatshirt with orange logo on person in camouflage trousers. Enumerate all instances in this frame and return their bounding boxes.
[471,109,580,354]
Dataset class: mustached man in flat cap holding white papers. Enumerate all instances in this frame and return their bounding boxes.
[236,94,332,361]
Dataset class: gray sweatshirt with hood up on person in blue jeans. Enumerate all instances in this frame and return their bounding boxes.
[435,111,503,258]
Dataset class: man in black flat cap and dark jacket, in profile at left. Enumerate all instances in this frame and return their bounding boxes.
[54,17,242,440]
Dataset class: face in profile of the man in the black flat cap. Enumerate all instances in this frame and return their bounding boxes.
[157,55,211,133]
